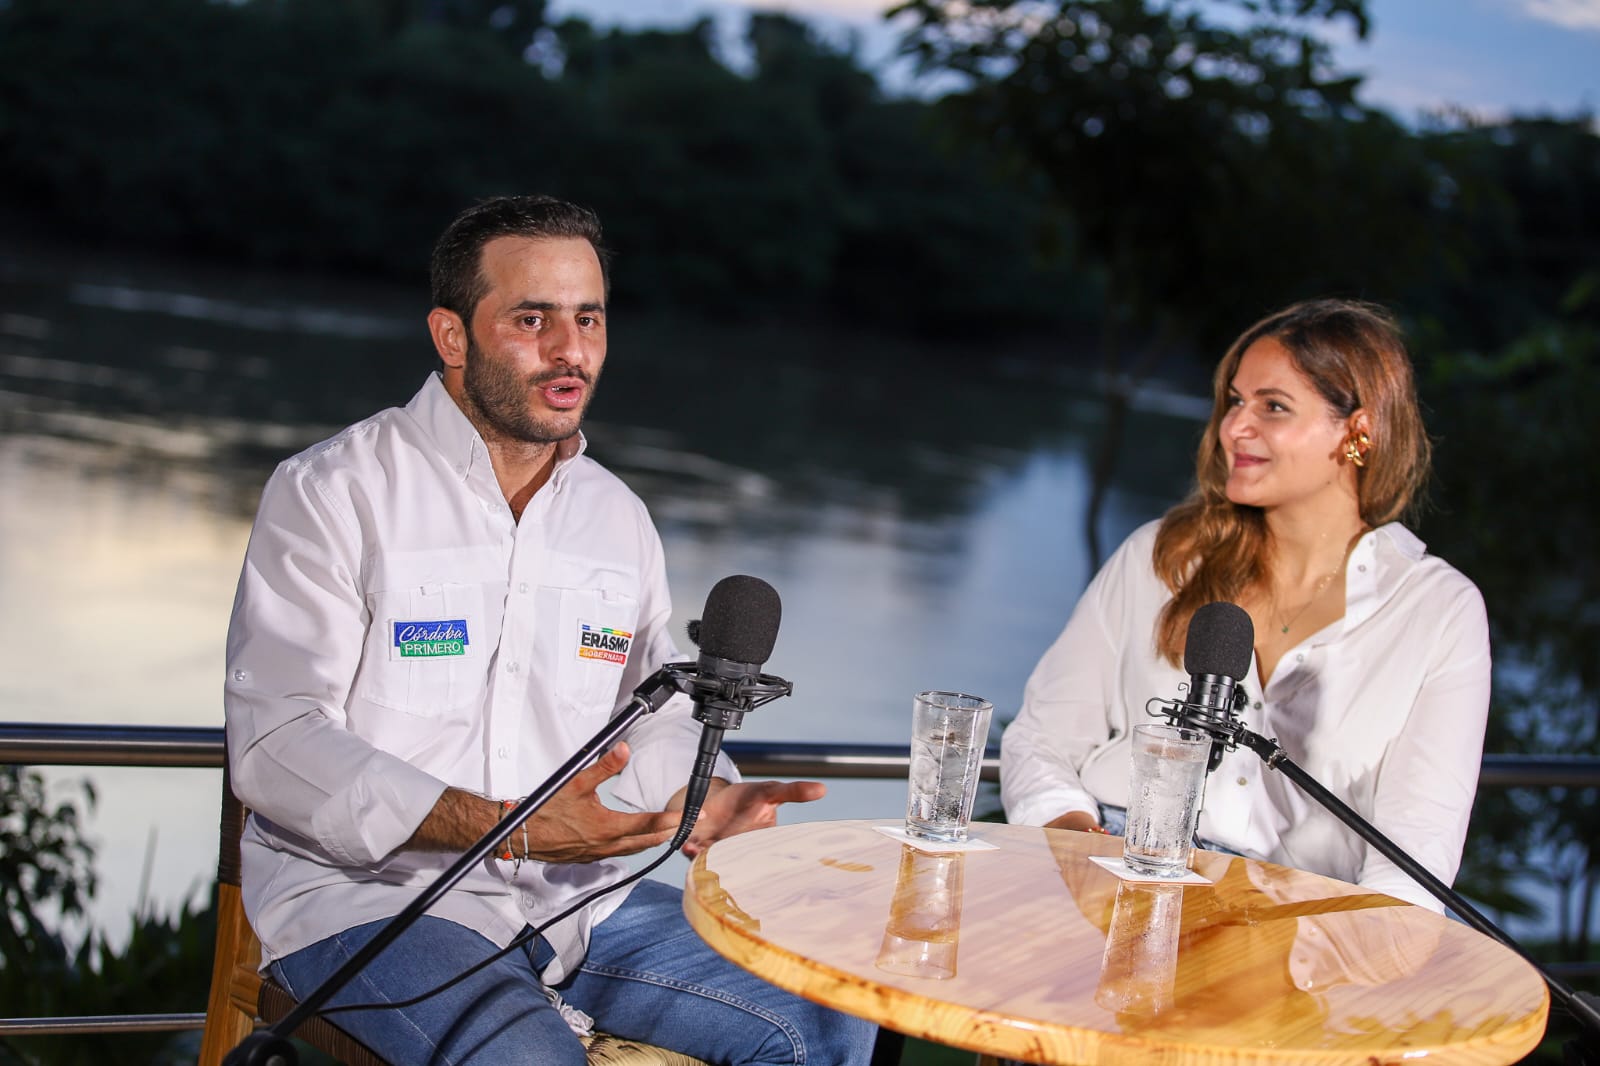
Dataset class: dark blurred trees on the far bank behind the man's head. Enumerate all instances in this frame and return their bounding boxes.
[0,0,1069,331]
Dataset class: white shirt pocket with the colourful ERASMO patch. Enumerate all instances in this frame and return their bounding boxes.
[549,587,638,715]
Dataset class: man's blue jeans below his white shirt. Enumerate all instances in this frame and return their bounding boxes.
[272,880,877,1066]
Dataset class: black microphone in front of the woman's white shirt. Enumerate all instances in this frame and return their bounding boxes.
[1144,600,1256,773]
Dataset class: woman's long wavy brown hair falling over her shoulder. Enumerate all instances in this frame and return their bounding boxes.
[1152,299,1432,666]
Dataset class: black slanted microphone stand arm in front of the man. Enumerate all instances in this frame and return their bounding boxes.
[222,663,690,1066]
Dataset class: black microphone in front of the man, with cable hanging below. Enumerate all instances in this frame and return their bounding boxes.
[662,575,794,848]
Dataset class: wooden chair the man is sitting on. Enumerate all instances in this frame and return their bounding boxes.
[200,765,706,1066]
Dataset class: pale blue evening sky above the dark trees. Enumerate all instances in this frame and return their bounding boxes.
[550,0,1600,122]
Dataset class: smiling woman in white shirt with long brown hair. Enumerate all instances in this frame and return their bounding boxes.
[1000,299,1490,911]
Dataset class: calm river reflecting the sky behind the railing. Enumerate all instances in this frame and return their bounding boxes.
[21,235,1523,943]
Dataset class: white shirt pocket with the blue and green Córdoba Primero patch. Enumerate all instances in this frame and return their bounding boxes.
[355,581,493,719]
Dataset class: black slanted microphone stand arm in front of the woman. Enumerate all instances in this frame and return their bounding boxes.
[1146,688,1600,1040]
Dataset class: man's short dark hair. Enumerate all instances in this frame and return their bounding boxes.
[429,195,611,316]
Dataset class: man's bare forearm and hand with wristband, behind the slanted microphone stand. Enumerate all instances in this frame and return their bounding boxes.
[406,744,678,863]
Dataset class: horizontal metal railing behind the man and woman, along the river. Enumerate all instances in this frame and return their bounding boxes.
[0,722,1600,1036]
